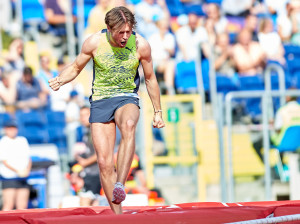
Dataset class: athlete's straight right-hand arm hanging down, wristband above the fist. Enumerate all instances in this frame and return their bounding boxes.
[137,35,165,128]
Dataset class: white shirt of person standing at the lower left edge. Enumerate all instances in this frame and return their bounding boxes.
[0,136,30,178]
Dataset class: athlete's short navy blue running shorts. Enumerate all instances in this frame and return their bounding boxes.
[89,96,140,123]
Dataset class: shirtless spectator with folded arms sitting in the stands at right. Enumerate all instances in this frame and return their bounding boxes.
[232,29,266,76]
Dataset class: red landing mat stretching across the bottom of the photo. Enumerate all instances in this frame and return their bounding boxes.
[0,201,300,224]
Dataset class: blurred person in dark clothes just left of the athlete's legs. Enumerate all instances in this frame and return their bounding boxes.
[73,106,101,206]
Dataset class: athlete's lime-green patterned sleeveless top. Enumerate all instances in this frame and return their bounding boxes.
[90,30,140,101]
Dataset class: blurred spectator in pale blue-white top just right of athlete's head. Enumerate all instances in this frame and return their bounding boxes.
[135,0,170,39]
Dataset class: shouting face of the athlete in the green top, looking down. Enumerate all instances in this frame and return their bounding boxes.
[108,23,132,48]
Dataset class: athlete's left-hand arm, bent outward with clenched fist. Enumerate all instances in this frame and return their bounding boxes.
[49,34,98,91]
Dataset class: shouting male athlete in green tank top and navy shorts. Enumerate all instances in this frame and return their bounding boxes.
[49,6,165,214]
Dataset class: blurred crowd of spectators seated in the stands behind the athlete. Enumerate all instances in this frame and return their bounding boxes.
[0,0,300,208]
